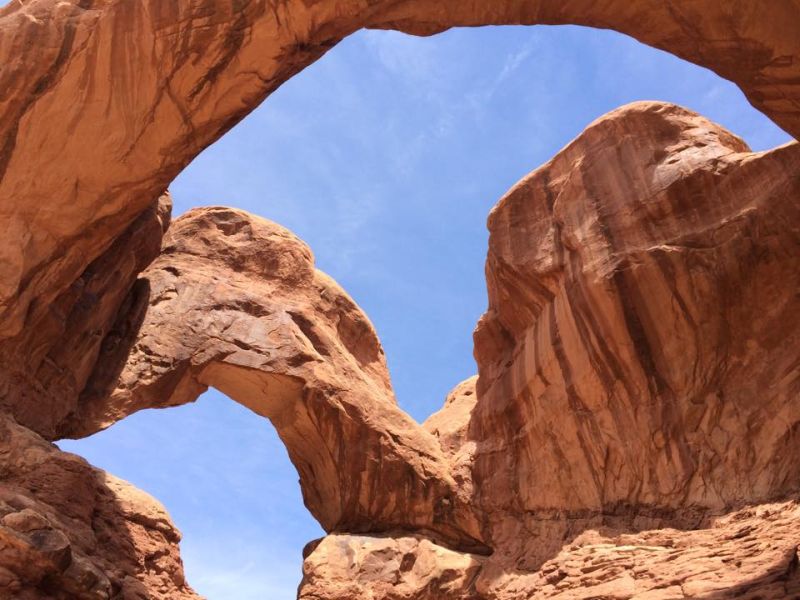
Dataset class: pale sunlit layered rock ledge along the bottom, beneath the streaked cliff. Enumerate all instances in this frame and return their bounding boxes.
[300,502,800,600]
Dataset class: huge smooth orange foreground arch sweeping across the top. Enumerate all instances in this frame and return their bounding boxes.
[0,0,800,376]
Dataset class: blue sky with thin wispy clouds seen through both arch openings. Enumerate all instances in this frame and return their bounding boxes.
[59,26,789,600]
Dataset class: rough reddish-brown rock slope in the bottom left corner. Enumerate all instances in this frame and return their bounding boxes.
[0,415,198,600]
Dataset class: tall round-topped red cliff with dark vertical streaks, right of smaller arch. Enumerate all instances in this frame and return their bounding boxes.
[470,103,800,512]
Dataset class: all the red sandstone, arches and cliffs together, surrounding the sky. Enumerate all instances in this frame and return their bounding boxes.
[0,0,800,600]
